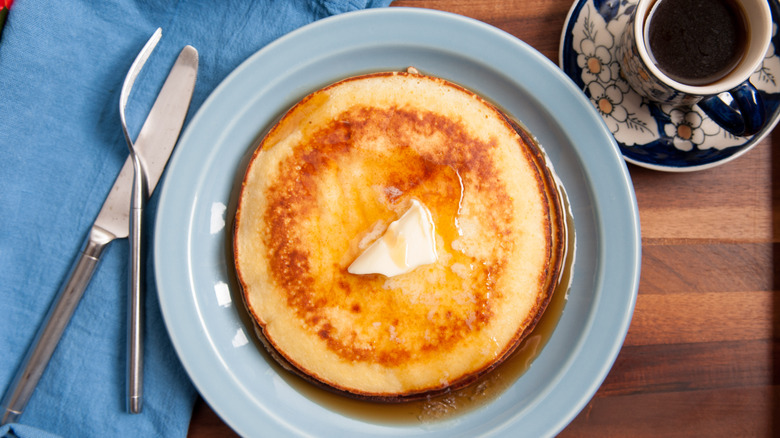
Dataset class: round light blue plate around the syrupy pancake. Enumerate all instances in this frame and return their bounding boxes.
[154,8,640,437]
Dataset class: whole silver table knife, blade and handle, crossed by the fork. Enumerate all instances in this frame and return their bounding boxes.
[0,42,198,424]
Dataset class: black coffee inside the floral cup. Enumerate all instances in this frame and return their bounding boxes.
[645,0,747,85]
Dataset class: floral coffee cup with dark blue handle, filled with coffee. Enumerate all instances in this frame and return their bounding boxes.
[617,0,772,136]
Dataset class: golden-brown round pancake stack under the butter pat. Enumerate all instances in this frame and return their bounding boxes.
[233,72,565,402]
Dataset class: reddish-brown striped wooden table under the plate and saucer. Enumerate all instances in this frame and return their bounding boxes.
[189,0,780,437]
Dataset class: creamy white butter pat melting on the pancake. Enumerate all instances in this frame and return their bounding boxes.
[347,199,438,277]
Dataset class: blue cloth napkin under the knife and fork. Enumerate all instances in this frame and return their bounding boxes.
[0,0,390,438]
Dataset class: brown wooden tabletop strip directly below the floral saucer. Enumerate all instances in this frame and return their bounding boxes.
[631,134,780,243]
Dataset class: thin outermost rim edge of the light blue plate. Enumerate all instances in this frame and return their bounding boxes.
[154,7,641,433]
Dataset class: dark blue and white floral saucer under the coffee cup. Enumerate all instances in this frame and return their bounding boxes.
[559,0,780,172]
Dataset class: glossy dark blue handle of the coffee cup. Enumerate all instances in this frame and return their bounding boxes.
[698,81,766,136]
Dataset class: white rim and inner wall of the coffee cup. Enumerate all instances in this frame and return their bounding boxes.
[633,0,772,96]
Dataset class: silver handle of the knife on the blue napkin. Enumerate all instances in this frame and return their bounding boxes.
[0,226,114,424]
